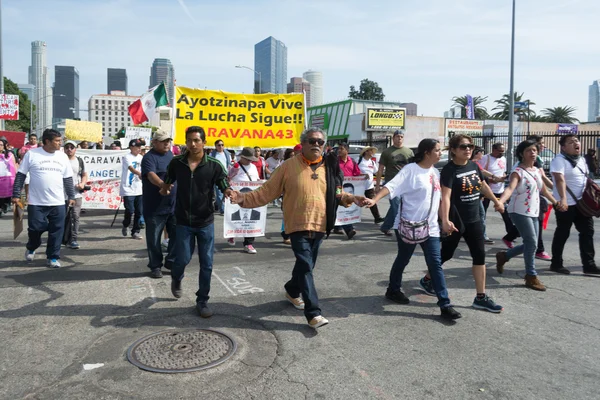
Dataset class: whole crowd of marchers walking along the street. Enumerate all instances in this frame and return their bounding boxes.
[0,126,600,328]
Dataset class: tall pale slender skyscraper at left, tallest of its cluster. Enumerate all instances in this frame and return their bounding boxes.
[29,40,52,136]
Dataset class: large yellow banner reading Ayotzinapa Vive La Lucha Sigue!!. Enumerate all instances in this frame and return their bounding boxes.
[174,86,304,149]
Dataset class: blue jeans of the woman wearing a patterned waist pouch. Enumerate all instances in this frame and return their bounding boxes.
[389,233,450,308]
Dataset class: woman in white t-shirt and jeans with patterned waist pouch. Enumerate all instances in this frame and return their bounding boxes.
[365,139,461,320]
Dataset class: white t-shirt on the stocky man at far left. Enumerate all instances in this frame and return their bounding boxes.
[18,147,73,206]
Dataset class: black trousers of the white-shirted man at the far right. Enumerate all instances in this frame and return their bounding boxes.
[551,206,596,269]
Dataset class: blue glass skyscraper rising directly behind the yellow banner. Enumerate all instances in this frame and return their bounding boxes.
[254,36,287,93]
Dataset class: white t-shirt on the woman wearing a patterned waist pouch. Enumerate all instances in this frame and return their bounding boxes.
[385,163,442,237]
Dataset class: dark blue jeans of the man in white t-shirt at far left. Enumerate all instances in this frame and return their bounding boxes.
[25,205,66,260]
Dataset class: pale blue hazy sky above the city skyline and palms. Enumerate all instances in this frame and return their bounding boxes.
[2,0,600,121]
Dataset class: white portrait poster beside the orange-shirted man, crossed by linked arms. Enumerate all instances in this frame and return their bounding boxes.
[223,181,267,238]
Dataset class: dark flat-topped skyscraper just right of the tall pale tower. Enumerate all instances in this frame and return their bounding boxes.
[52,65,79,124]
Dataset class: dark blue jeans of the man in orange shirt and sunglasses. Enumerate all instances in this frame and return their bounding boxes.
[285,232,325,321]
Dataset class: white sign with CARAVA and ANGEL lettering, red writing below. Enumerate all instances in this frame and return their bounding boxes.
[77,149,129,210]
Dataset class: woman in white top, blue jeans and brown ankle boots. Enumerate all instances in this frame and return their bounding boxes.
[496,140,561,291]
